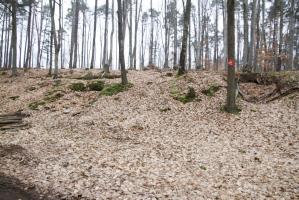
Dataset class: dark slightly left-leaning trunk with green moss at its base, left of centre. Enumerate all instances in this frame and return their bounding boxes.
[117,0,128,85]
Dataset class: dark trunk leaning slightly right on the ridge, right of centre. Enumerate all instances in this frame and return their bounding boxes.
[178,0,191,75]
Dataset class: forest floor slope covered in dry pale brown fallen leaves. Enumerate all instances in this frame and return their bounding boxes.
[0,70,299,199]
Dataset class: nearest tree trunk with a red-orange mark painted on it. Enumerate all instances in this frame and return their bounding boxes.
[225,0,237,113]
